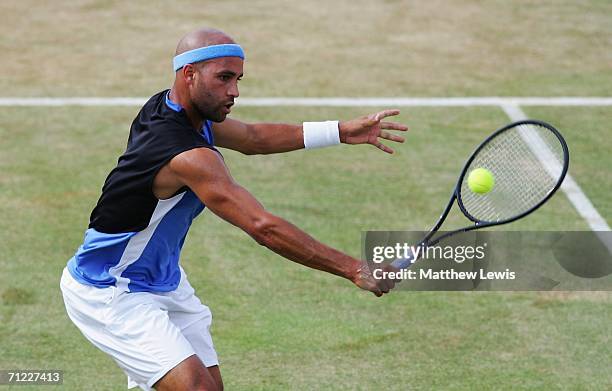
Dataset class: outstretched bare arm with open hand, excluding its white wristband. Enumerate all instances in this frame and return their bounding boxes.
[213,110,408,155]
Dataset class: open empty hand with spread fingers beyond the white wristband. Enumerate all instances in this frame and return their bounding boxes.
[339,110,408,153]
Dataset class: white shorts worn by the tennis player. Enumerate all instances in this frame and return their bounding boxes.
[60,269,219,390]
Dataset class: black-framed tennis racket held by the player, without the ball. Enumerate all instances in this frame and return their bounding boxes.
[391,120,569,269]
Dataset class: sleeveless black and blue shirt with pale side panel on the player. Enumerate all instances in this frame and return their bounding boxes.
[68,90,216,292]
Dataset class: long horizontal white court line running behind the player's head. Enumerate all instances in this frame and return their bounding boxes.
[0,96,612,107]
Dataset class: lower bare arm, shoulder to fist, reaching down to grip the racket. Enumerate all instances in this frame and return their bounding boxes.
[169,148,393,296]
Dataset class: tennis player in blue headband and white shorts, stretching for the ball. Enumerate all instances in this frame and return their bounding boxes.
[60,29,406,391]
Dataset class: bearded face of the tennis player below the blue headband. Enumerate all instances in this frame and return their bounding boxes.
[189,57,244,122]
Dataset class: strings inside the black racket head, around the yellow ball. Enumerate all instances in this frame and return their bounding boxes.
[461,124,565,222]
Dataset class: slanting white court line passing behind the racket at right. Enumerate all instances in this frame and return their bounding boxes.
[502,105,612,245]
